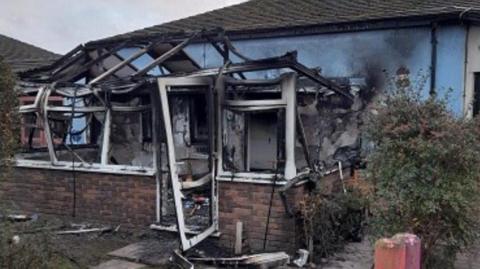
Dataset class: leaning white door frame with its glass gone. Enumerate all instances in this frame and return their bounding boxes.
[158,77,218,251]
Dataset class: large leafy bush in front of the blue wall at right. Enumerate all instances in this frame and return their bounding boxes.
[365,87,480,268]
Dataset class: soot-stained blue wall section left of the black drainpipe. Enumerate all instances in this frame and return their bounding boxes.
[187,27,432,90]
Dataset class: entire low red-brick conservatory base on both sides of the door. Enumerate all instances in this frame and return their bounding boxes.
[0,168,346,253]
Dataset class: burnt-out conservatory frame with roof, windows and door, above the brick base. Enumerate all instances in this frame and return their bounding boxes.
[16,31,358,251]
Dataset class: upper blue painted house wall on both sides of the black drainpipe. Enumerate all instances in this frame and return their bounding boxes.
[186,26,466,114]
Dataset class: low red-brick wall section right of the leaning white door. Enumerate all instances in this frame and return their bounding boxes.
[219,182,305,252]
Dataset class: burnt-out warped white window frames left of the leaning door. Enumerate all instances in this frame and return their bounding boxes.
[17,84,153,174]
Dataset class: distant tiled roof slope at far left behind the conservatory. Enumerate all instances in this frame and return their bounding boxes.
[0,34,60,72]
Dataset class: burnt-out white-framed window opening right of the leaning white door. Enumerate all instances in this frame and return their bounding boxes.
[219,74,296,178]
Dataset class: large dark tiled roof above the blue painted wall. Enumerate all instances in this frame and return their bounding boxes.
[90,0,480,45]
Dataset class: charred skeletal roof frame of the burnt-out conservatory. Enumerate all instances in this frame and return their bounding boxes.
[20,30,353,100]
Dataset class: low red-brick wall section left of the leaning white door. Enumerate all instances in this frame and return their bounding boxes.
[0,168,156,226]
